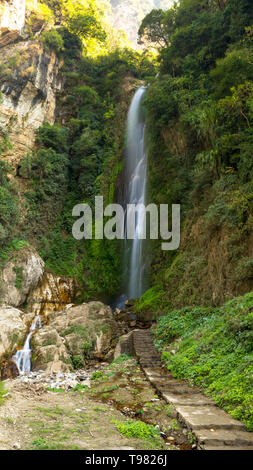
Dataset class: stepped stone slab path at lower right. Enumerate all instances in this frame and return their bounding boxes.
[132,330,253,450]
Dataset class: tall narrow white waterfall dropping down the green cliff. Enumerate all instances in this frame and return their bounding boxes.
[114,87,149,308]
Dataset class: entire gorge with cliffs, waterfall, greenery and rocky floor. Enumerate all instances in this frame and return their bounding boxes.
[0,0,253,450]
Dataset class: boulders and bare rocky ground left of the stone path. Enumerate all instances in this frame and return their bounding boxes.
[0,246,195,450]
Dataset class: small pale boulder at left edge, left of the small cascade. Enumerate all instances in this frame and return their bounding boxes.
[0,307,26,356]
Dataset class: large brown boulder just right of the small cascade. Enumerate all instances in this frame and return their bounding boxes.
[33,302,120,373]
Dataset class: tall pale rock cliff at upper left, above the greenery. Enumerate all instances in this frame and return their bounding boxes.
[0,41,61,169]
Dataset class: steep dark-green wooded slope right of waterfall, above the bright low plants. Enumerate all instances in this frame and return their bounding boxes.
[134,0,253,315]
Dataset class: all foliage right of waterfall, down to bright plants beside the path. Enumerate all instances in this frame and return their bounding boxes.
[136,0,253,430]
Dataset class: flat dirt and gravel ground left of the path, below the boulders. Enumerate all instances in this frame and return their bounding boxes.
[0,356,195,450]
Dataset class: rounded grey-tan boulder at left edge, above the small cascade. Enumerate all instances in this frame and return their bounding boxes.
[0,246,45,307]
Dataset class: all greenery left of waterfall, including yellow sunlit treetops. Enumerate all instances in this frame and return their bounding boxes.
[0,0,156,302]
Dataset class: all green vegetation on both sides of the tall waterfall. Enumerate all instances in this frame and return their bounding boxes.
[0,0,253,436]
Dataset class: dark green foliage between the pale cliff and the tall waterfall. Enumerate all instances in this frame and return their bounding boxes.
[14,23,155,301]
